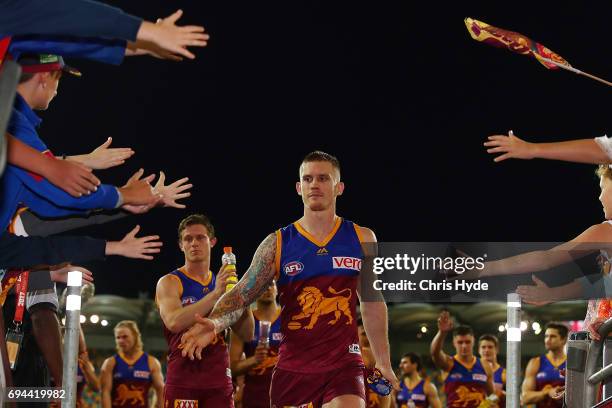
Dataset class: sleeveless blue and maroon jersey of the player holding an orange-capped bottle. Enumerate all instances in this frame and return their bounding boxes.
[162,268,232,389]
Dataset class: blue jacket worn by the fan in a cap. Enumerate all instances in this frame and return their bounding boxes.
[0,94,119,230]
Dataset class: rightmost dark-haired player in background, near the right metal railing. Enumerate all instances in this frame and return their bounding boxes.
[521,322,569,408]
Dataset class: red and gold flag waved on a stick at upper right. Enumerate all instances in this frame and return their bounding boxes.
[465,17,571,69]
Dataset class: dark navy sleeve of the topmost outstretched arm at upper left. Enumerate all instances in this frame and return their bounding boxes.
[0,0,142,41]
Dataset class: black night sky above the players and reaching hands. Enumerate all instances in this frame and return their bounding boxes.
[35,0,612,296]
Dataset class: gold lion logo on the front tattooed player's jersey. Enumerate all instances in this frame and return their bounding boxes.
[288,286,353,330]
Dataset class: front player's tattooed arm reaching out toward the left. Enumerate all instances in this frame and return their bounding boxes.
[181,234,276,359]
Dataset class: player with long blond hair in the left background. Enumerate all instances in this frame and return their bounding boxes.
[100,320,164,408]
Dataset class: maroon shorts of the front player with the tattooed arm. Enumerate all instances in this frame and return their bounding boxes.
[270,366,366,408]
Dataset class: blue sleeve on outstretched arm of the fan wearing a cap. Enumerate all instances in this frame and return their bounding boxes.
[15,169,119,217]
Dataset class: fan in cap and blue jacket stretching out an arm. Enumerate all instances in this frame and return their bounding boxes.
[0,54,164,233]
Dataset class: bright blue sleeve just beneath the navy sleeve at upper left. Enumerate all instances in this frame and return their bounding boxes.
[8,35,126,65]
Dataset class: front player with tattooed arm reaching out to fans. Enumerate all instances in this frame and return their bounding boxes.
[181,151,399,408]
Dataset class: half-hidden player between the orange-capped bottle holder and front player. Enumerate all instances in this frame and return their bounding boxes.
[230,283,281,408]
